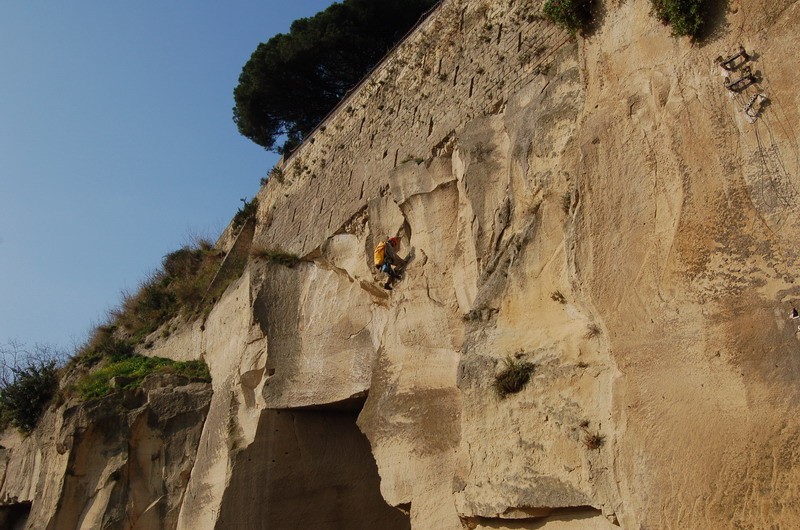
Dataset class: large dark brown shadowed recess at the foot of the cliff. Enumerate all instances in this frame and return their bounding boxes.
[217,397,410,530]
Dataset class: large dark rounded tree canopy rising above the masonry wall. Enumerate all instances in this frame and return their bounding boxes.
[233,0,438,153]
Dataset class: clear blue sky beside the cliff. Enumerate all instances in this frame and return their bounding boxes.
[0,0,333,348]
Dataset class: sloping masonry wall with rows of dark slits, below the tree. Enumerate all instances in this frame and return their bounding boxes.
[255,0,570,255]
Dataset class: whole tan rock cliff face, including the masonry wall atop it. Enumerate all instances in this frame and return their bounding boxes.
[0,0,800,530]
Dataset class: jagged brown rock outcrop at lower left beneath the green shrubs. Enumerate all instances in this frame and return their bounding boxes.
[0,376,211,530]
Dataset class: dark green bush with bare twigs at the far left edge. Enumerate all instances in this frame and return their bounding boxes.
[0,360,58,433]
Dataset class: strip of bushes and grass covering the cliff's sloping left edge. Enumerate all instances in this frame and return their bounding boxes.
[0,234,230,433]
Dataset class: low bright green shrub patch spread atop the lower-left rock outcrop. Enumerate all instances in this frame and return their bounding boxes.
[75,354,211,399]
